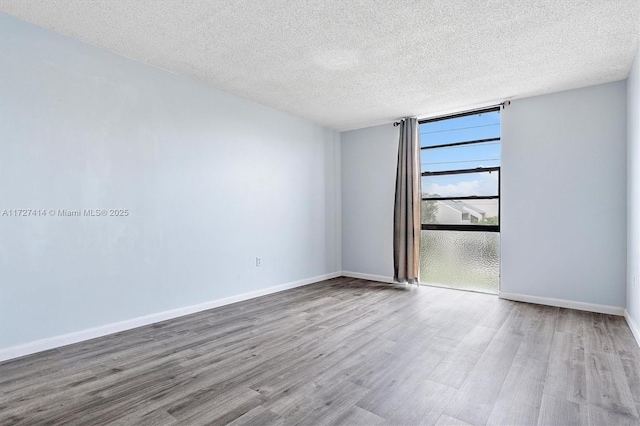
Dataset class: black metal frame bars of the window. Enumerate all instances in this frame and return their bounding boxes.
[418,106,502,232]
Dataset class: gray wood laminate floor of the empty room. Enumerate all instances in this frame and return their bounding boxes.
[0,278,640,426]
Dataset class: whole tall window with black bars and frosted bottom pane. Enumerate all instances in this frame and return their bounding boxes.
[420,107,500,293]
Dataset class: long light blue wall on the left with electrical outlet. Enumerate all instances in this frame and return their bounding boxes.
[0,15,341,348]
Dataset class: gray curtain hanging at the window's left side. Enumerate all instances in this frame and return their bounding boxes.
[393,118,422,284]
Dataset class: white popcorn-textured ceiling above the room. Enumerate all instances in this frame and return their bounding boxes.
[0,0,640,130]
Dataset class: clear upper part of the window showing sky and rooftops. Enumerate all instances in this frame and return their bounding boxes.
[420,108,500,232]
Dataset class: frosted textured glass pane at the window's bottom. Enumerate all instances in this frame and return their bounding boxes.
[420,231,500,294]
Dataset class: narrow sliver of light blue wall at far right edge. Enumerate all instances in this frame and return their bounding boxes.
[627,53,640,330]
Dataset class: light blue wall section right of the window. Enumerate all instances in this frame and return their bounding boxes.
[501,81,627,307]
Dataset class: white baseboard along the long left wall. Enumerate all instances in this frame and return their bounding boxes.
[0,271,342,361]
